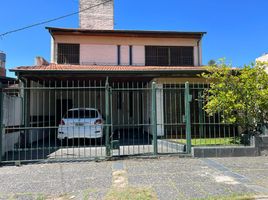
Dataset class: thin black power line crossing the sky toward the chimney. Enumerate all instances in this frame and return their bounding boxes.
[0,0,112,38]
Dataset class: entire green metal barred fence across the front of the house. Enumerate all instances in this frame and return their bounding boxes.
[0,79,237,162]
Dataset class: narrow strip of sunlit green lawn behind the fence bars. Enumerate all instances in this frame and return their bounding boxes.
[169,137,240,146]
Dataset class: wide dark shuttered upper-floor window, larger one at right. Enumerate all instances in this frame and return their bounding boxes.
[145,46,194,66]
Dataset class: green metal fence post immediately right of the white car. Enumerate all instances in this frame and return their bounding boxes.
[105,78,111,156]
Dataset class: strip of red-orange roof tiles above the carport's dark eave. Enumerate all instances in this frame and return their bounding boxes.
[10,64,205,72]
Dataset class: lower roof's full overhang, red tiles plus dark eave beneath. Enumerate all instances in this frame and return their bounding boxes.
[10,64,206,78]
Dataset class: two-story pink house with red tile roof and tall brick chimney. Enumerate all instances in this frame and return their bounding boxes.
[11,0,205,145]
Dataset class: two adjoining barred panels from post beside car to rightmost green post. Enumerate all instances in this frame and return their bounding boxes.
[110,82,194,156]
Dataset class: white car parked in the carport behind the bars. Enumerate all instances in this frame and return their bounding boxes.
[58,108,103,140]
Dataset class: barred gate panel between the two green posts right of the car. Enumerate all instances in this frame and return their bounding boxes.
[110,82,153,156]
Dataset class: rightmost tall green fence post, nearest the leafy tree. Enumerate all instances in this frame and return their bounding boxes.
[185,82,192,153]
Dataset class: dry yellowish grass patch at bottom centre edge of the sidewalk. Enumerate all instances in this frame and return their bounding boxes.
[104,187,157,200]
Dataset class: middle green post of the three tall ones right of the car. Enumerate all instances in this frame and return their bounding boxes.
[151,82,157,155]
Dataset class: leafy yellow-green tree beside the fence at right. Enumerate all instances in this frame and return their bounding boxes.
[201,60,268,133]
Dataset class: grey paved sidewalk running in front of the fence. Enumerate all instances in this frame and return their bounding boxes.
[0,157,268,200]
